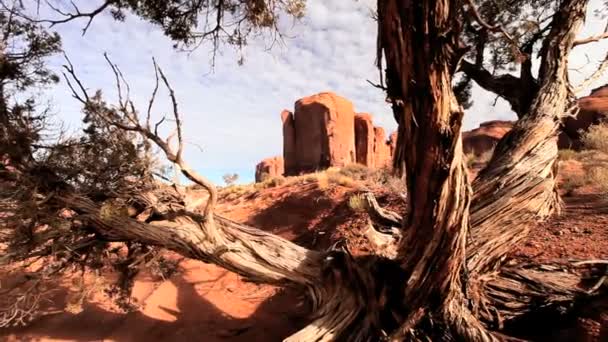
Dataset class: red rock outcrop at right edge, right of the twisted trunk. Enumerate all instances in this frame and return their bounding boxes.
[558,85,608,149]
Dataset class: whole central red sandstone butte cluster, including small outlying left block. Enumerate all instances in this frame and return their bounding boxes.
[255,92,396,182]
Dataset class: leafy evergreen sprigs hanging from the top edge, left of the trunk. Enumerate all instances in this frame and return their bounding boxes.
[38,0,306,56]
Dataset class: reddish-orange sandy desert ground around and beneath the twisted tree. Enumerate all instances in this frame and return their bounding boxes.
[0,156,608,342]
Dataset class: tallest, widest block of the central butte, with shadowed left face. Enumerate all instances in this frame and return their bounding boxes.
[290,92,355,172]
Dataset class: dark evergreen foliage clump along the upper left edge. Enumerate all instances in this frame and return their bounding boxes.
[0,11,61,165]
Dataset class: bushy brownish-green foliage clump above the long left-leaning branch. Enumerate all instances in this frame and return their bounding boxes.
[38,91,158,194]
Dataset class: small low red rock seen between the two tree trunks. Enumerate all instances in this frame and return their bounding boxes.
[462,120,513,155]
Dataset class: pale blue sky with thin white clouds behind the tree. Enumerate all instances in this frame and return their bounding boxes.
[32,0,608,184]
